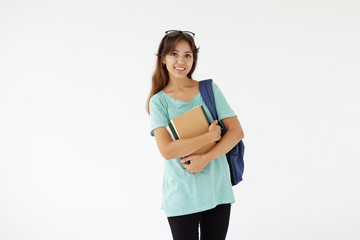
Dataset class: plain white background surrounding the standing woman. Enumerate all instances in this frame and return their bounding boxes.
[0,0,360,240]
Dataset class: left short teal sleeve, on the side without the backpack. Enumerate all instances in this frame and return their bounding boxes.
[149,95,169,136]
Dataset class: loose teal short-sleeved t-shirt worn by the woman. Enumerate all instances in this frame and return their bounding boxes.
[150,82,236,217]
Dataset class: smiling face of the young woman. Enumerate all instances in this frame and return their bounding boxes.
[163,40,194,79]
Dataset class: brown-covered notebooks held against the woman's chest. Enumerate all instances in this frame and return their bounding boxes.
[166,105,216,154]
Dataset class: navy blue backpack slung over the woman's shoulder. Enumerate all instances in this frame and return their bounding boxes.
[199,79,245,186]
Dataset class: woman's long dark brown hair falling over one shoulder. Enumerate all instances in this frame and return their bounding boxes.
[146,31,199,114]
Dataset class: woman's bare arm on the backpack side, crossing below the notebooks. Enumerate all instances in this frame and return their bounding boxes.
[181,117,244,173]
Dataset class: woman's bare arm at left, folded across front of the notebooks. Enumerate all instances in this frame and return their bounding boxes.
[154,121,221,160]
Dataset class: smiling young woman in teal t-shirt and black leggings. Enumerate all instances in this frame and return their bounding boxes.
[147,30,244,240]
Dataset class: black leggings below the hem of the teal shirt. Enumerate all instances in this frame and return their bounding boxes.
[168,204,230,240]
